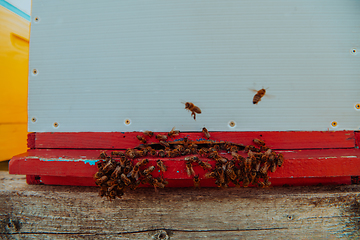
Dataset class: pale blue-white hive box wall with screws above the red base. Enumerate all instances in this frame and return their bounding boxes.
[28,0,360,132]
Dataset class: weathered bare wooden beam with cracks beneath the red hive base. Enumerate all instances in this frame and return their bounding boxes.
[0,172,360,239]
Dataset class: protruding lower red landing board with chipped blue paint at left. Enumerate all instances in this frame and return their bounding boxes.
[9,149,360,186]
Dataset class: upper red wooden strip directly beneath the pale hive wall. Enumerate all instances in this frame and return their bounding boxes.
[29,131,355,149]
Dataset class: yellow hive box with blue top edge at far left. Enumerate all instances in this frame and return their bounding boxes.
[0,0,30,161]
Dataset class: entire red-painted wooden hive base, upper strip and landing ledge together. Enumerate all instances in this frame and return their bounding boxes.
[9,131,360,187]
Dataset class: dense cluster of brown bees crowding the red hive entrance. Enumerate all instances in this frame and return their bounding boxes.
[94,125,284,200]
